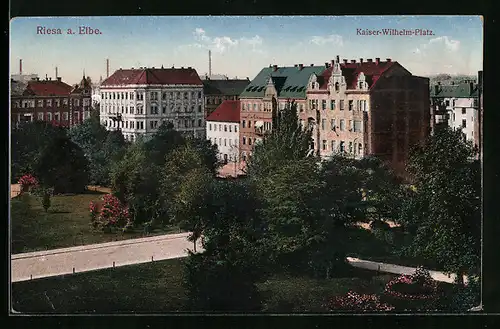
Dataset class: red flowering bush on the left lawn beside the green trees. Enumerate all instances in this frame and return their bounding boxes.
[89,194,131,231]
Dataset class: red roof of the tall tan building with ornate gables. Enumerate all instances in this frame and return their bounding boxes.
[318,61,399,89]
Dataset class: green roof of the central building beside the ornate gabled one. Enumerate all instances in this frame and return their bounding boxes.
[240,66,325,98]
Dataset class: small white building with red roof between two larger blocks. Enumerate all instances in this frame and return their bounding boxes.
[207,100,240,163]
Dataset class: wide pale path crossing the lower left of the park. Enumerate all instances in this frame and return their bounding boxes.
[11,233,202,282]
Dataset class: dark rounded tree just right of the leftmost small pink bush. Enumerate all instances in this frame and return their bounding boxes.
[34,137,88,193]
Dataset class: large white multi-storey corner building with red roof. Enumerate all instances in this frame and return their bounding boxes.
[100,67,206,141]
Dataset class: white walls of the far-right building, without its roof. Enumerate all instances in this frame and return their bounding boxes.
[444,98,479,141]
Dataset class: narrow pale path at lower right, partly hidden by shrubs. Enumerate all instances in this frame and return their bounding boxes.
[347,257,467,283]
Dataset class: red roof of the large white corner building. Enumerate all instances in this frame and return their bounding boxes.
[102,67,203,86]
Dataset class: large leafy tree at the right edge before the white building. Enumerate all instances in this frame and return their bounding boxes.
[399,128,481,281]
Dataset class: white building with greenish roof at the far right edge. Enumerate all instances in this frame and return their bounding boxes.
[430,81,480,147]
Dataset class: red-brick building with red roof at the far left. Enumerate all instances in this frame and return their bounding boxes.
[11,76,91,127]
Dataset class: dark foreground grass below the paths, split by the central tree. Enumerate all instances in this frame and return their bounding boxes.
[12,259,392,313]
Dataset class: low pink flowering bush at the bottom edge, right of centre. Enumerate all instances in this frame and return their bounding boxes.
[326,291,394,312]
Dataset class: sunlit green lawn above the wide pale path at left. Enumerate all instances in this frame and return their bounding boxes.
[10,191,179,254]
